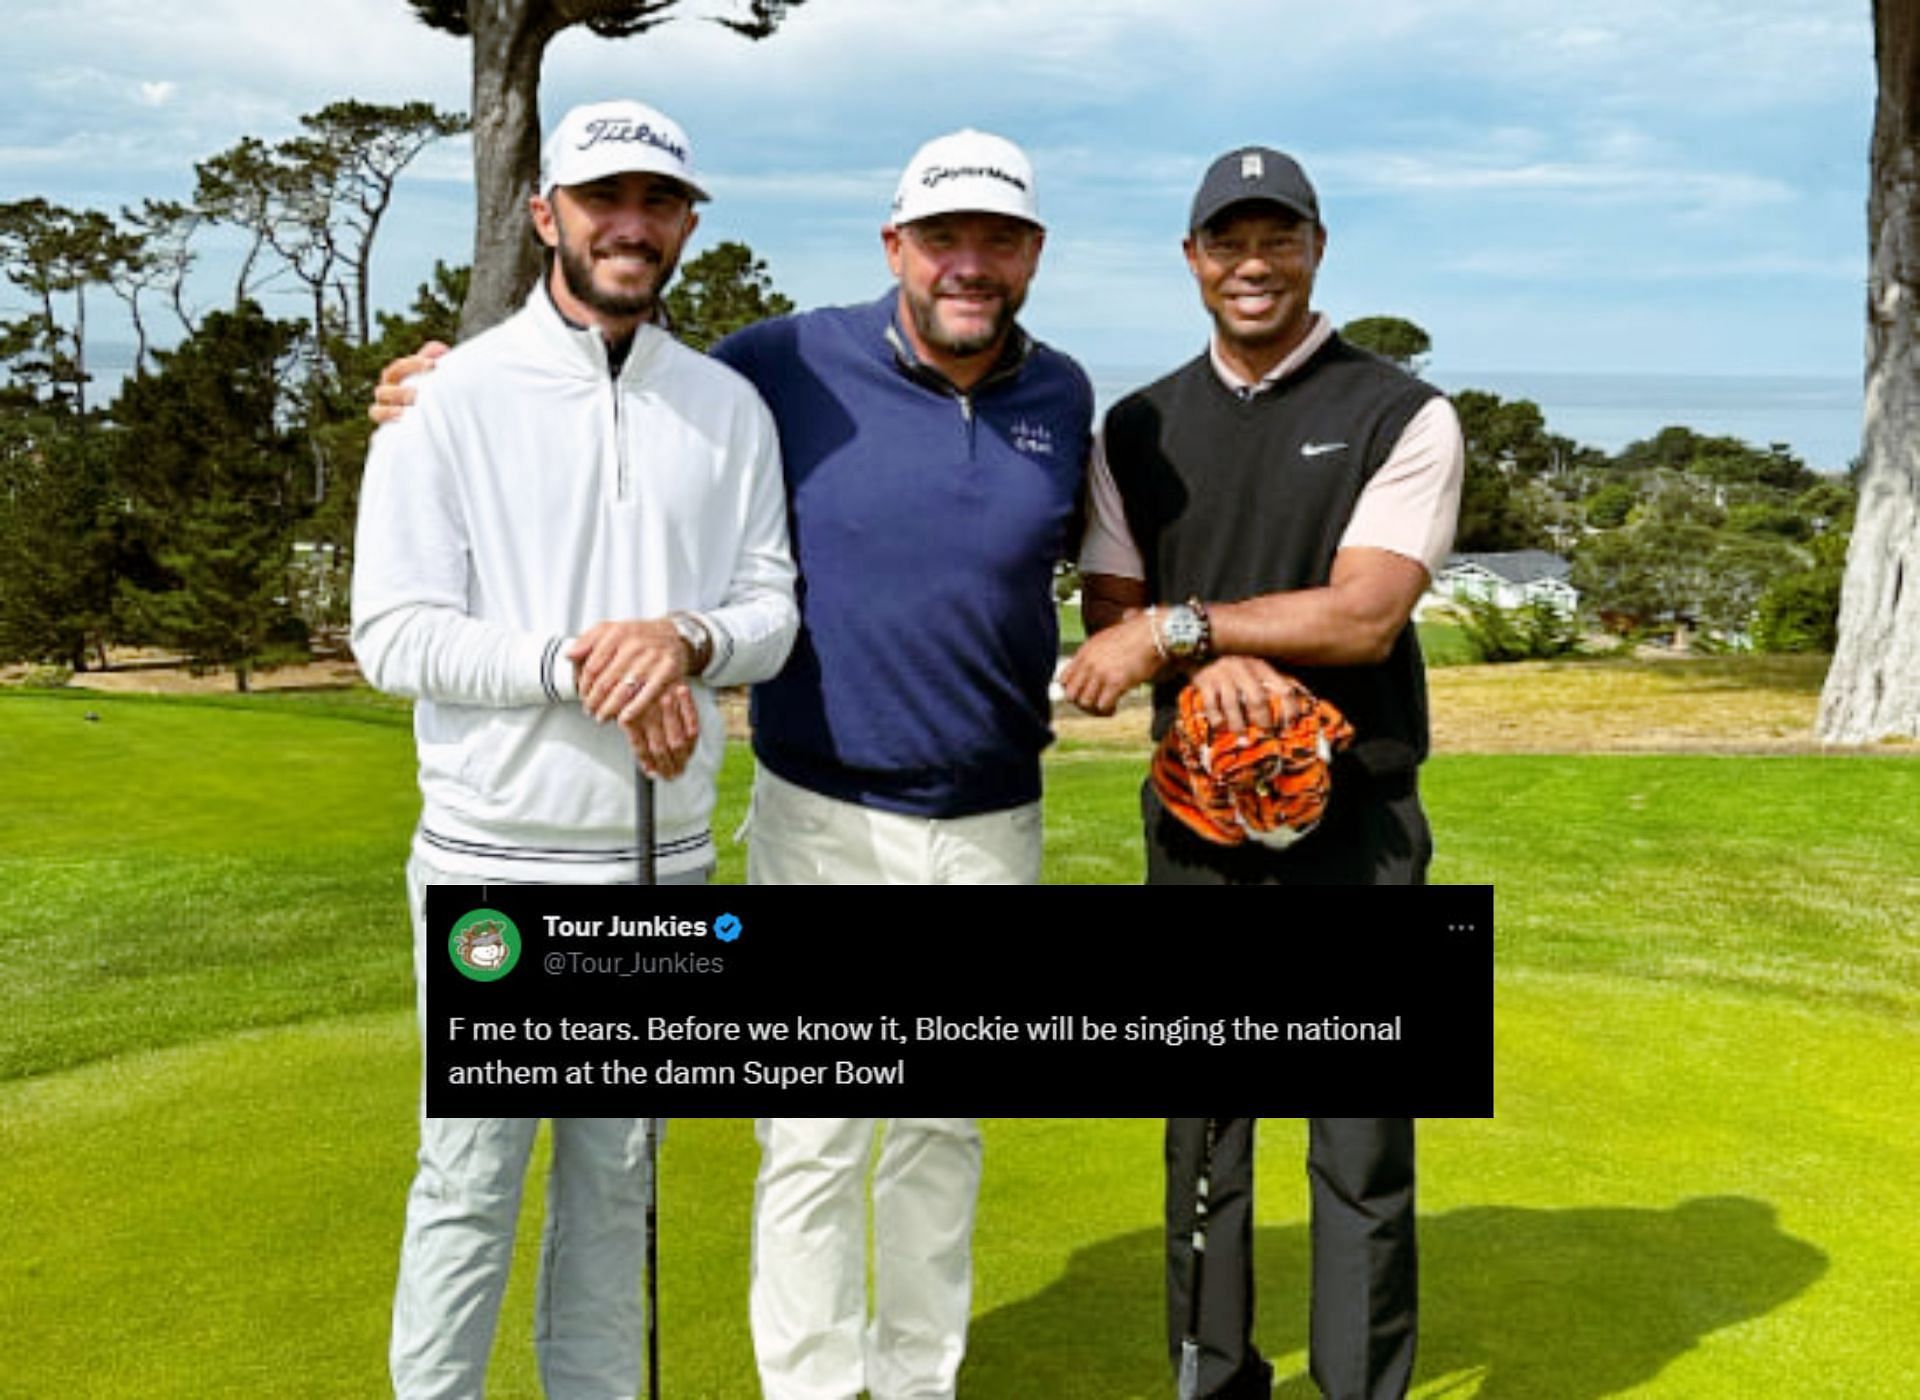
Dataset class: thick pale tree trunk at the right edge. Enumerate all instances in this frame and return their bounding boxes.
[1820,0,1920,743]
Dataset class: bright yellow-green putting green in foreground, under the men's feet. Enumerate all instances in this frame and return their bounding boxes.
[0,972,1920,1400]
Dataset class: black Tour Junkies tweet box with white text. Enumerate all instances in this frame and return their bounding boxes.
[424,885,1494,1118]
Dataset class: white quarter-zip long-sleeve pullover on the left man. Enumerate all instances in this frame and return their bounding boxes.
[353,288,799,883]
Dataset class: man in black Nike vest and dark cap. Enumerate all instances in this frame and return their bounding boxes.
[1062,146,1463,1400]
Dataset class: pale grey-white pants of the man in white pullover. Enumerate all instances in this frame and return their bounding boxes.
[388,857,699,1400]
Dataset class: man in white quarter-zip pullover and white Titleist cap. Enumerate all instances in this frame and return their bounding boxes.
[353,102,797,1400]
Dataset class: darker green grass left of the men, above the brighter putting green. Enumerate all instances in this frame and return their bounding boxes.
[0,691,419,1075]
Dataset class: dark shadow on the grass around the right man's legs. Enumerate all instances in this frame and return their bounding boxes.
[962,1196,1828,1400]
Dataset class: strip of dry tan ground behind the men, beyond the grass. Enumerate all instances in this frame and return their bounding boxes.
[11,651,1920,753]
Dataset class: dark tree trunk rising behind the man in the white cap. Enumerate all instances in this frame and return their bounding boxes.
[461,0,563,340]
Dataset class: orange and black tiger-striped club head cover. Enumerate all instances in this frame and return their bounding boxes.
[1152,686,1354,851]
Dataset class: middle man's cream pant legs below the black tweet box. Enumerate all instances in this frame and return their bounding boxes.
[751,1118,981,1400]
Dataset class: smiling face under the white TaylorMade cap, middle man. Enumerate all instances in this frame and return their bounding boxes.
[881,213,1044,388]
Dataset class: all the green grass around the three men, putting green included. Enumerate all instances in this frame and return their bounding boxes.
[0,693,1920,1400]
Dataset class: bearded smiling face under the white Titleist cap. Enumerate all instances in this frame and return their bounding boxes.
[532,171,699,338]
